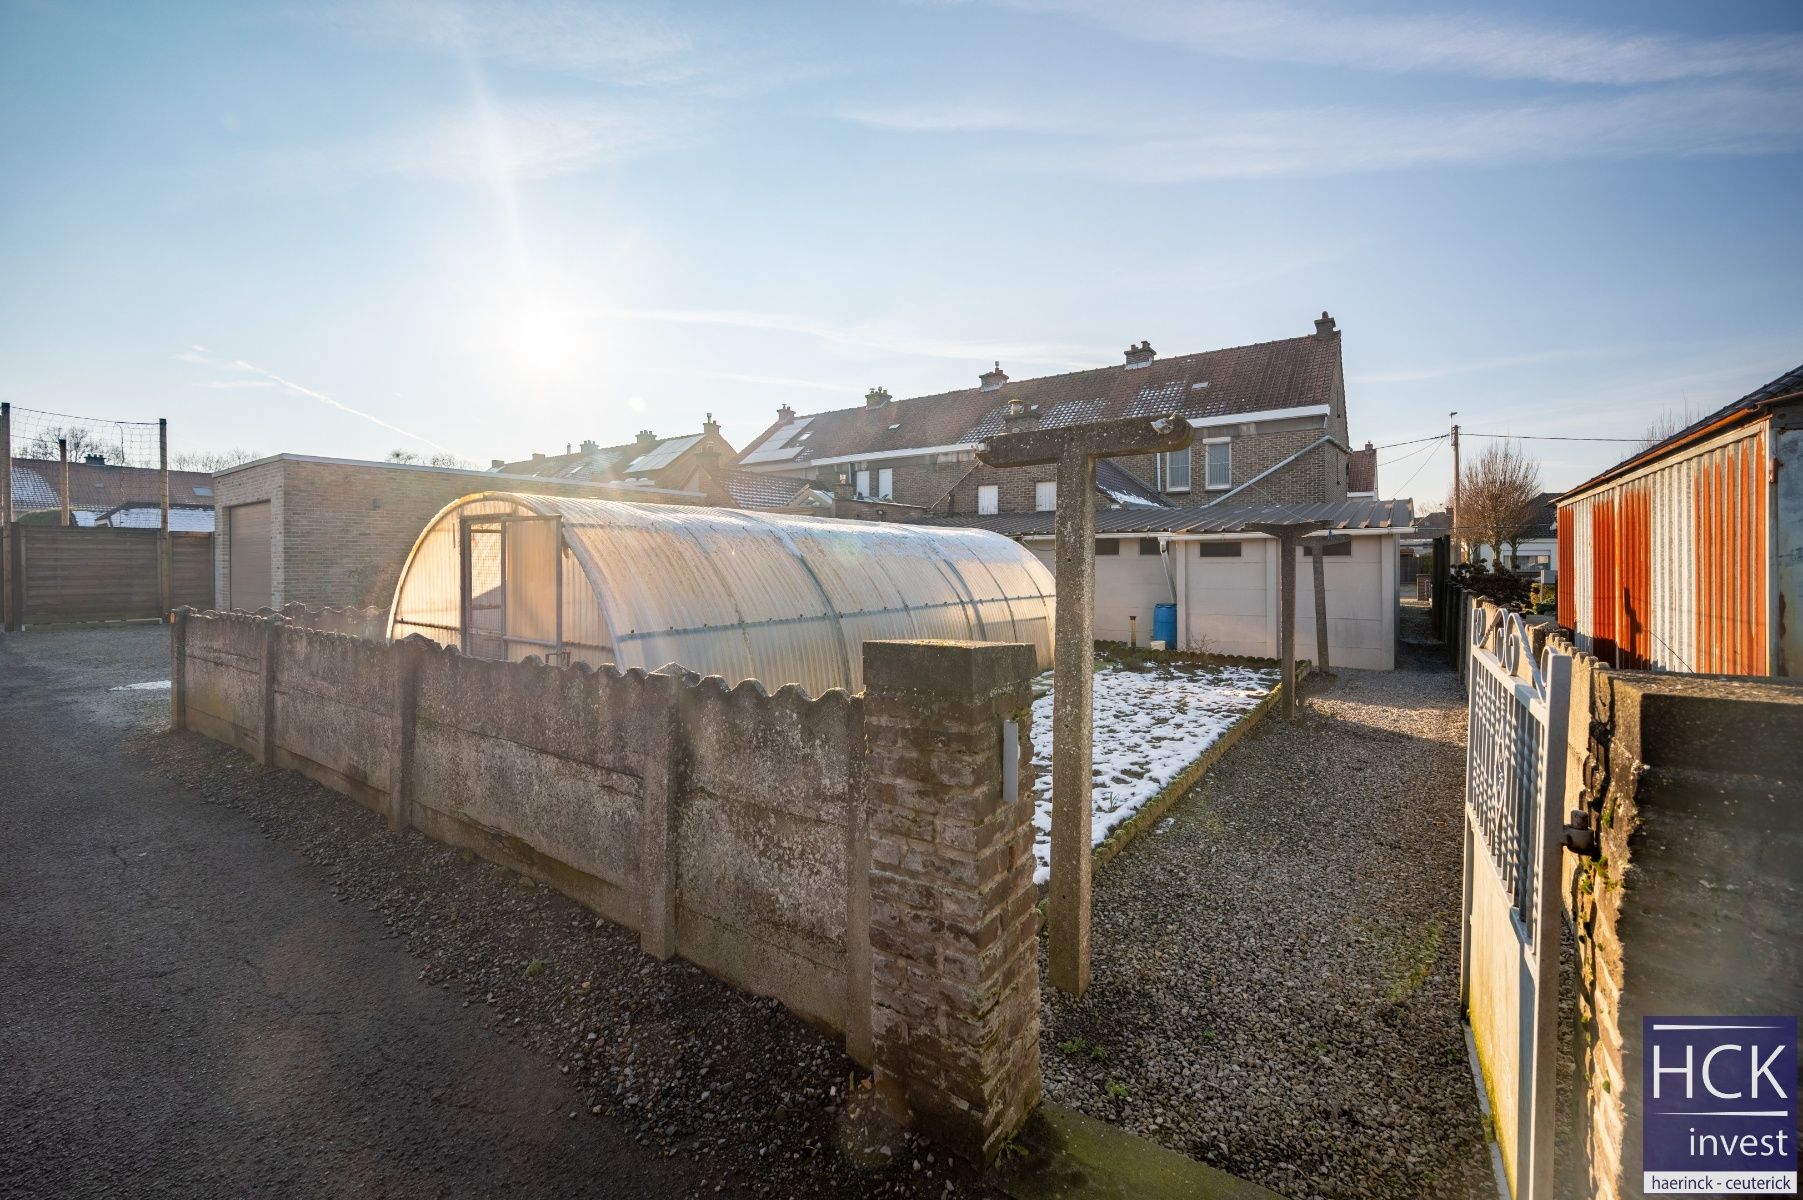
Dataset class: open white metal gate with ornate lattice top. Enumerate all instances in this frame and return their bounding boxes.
[1459,600,1572,1200]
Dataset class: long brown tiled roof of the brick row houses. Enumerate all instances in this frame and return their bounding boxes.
[739,333,1340,467]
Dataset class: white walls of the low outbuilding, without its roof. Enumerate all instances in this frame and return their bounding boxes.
[1026,533,1397,670]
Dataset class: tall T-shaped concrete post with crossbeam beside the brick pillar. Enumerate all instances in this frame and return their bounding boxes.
[977,414,1194,996]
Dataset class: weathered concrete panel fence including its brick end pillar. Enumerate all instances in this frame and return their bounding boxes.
[171,609,1039,1160]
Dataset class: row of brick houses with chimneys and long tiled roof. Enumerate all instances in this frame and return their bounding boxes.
[737,312,1355,519]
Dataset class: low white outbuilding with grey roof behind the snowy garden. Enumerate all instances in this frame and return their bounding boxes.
[941,499,1414,670]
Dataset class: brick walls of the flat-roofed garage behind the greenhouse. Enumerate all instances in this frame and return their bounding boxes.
[213,458,700,607]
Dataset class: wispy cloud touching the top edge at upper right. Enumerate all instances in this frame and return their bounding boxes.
[1002,0,1803,85]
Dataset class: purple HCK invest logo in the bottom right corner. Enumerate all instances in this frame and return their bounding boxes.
[1641,1016,1798,1196]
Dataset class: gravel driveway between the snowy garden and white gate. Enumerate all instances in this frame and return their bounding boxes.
[1042,609,1496,1200]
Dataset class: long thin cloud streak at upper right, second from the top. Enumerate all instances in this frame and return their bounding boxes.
[842,85,1803,182]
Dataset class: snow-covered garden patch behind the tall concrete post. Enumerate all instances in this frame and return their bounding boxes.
[1033,661,1280,883]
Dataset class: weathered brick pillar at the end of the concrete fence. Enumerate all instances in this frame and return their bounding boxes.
[864,641,1039,1162]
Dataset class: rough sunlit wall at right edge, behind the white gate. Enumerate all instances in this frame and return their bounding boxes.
[1556,655,1803,1200]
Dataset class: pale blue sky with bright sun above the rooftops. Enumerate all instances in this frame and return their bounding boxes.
[0,0,1803,501]
